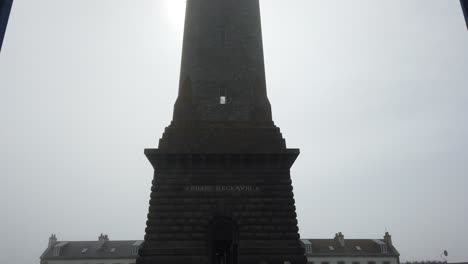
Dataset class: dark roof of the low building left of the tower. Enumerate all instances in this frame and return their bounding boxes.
[41,237,143,260]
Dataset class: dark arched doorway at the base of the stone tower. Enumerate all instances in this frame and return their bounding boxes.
[210,217,238,264]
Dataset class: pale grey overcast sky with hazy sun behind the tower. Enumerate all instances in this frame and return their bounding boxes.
[0,0,468,264]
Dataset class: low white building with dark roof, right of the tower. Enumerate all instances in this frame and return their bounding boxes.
[301,233,400,264]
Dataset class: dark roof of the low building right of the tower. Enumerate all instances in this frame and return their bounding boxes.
[301,233,400,257]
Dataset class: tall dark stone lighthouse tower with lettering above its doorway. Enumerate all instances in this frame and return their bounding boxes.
[138,0,306,264]
